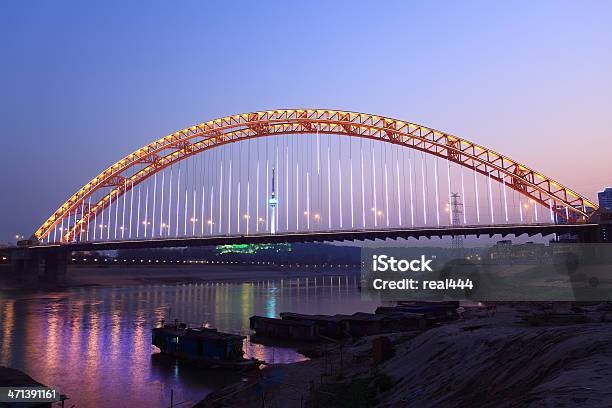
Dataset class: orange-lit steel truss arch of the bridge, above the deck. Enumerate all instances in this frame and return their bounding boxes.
[33,109,597,243]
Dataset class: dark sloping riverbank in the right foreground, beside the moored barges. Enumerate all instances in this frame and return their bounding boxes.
[195,306,612,408]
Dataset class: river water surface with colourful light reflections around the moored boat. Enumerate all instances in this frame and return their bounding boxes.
[0,275,376,407]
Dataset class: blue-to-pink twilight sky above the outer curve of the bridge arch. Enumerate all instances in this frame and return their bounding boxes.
[0,1,612,242]
